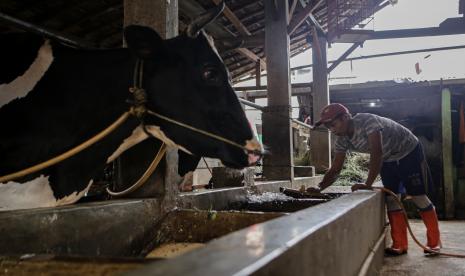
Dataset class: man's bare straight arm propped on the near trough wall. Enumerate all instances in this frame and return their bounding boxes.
[365,131,383,187]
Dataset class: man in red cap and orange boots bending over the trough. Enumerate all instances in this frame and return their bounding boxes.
[307,103,441,256]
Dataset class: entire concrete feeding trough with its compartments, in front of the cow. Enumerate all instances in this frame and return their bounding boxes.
[0,178,384,275]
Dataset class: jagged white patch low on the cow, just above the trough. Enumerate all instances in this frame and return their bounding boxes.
[0,175,92,211]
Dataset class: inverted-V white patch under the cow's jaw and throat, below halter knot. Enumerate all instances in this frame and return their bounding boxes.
[107,125,192,163]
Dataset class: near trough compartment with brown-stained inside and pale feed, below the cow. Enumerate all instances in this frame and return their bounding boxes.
[0,203,283,275]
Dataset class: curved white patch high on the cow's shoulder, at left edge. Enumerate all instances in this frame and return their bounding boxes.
[0,40,53,107]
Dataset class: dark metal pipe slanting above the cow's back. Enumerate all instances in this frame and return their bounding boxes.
[0,12,96,48]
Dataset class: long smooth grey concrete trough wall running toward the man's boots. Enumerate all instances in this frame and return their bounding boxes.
[127,191,385,275]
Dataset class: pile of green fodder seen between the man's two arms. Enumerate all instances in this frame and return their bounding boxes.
[334,153,370,186]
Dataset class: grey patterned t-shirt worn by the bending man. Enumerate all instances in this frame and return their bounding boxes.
[334,113,418,162]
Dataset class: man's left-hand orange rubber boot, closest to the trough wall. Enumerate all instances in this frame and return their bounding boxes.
[384,211,408,256]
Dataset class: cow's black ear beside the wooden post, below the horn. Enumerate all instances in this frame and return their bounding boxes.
[124,25,163,58]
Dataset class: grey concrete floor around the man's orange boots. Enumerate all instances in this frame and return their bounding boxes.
[380,220,465,276]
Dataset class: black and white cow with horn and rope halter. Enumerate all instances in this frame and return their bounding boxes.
[0,5,262,210]
